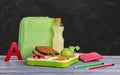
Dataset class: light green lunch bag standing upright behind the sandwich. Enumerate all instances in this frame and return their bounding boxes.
[18,17,55,59]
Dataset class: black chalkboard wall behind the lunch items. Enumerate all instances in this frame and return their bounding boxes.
[0,0,120,55]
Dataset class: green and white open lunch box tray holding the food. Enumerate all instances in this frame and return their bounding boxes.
[26,57,78,68]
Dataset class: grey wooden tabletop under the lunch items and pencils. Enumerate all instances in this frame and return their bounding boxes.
[0,56,120,75]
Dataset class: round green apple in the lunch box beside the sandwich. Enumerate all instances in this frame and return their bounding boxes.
[61,48,75,58]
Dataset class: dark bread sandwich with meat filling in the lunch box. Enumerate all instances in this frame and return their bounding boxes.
[32,46,59,58]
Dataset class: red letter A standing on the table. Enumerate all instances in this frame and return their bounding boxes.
[4,42,22,62]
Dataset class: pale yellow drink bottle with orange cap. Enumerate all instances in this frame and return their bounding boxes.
[53,18,64,53]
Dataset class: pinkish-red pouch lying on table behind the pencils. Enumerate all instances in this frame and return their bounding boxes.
[79,52,103,62]
